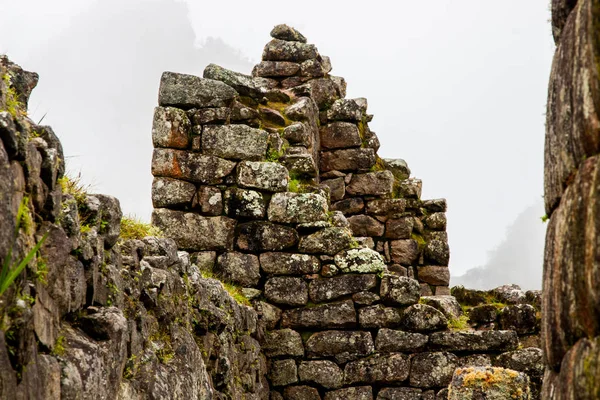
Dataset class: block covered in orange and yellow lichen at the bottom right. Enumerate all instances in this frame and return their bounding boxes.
[448,367,530,400]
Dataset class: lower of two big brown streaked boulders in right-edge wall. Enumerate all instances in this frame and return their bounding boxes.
[542,156,600,368]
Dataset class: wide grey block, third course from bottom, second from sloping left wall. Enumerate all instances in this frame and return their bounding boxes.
[306,331,374,364]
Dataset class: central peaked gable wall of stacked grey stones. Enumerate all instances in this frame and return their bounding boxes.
[152,25,540,400]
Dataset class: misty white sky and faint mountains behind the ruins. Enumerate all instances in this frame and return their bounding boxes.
[0,0,554,289]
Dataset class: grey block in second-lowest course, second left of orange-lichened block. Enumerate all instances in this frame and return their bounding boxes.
[344,353,410,385]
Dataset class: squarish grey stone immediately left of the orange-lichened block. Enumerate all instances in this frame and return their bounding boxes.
[410,352,458,388]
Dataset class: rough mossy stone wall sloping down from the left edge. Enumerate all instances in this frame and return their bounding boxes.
[0,58,268,400]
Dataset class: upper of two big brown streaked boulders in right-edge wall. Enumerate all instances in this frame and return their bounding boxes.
[544,0,600,215]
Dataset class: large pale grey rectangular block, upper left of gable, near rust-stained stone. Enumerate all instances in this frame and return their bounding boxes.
[202,124,267,160]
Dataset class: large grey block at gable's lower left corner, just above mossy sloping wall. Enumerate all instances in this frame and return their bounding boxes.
[152,208,236,251]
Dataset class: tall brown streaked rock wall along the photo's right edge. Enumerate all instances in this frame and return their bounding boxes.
[542,0,600,399]
